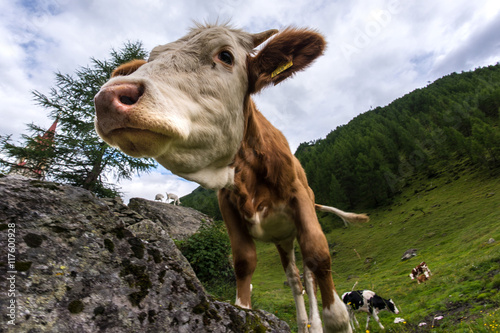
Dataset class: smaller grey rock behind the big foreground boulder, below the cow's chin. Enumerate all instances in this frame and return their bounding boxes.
[128,198,212,240]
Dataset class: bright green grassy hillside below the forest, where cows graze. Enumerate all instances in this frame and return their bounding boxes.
[244,165,500,332]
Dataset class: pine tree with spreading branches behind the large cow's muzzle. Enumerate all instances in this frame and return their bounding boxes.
[0,42,156,197]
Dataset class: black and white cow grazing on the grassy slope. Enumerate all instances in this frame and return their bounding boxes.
[342,290,399,330]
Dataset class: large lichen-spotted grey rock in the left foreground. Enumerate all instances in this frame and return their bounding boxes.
[0,177,290,333]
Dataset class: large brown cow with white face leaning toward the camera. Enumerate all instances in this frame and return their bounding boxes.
[94,24,369,333]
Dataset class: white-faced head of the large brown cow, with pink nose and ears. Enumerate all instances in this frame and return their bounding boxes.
[95,25,325,188]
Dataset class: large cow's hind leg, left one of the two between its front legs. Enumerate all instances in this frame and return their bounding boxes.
[276,240,308,333]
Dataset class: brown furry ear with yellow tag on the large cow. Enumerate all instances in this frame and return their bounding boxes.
[248,28,326,93]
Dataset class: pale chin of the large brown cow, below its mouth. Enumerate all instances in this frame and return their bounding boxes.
[109,128,171,157]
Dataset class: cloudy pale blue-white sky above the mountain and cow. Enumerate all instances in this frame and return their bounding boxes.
[0,0,500,203]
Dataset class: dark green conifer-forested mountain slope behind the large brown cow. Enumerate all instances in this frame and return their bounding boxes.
[182,64,500,218]
